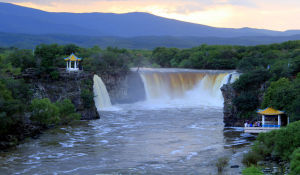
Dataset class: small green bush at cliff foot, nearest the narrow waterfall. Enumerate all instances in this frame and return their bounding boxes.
[55,99,81,124]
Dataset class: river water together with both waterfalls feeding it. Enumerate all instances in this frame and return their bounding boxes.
[0,69,253,175]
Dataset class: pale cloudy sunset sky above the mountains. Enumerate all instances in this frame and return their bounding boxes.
[2,0,300,31]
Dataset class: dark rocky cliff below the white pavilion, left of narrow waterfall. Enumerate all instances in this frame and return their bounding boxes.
[22,69,100,120]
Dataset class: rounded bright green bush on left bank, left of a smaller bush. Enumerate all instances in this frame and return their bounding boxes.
[30,98,60,127]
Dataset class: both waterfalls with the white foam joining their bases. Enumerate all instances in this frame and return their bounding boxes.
[94,68,239,111]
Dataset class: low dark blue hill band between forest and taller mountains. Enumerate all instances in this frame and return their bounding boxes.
[0,33,300,49]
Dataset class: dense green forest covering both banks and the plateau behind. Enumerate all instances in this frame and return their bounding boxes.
[0,41,300,174]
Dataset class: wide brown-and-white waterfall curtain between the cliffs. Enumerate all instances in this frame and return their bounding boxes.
[140,69,238,106]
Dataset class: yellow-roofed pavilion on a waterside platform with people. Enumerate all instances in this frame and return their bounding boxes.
[244,107,289,133]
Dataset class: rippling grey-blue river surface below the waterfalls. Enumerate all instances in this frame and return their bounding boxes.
[0,105,252,175]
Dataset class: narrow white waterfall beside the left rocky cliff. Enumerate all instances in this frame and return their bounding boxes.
[93,75,111,111]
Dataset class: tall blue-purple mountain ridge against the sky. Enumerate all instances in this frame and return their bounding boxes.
[0,3,300,38]
